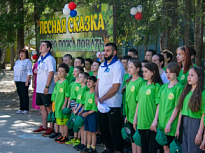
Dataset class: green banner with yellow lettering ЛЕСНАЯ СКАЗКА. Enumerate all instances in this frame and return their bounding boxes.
[37,4,113,58]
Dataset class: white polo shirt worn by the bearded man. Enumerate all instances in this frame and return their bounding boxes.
[98,61,125,107]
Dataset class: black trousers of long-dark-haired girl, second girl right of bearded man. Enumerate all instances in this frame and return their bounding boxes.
[139,129,163,153]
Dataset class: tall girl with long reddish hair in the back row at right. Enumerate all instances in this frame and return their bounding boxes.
[176,46,193,86]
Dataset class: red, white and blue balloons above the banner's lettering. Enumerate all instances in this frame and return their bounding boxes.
[63,2,77,17]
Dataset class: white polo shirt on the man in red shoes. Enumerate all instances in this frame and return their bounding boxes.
[36,55,56,94]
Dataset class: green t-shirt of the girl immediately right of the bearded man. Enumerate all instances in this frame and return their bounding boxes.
[125,77,144,123]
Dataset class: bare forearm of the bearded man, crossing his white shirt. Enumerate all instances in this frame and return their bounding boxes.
[99,83,120,103]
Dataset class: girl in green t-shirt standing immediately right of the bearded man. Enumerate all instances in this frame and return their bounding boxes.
[125,59,144,153]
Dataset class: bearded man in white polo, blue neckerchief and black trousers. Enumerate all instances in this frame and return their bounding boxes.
[95,43,125,153]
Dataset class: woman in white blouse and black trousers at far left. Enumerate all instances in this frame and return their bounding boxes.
[14,49,32,114]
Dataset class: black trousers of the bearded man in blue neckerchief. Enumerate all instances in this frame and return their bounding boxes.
[98,108,123,152]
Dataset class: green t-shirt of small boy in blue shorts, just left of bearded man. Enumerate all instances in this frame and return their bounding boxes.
[84,91,98,112]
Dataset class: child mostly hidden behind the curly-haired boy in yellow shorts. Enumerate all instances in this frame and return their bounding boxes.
[49,72,61,138]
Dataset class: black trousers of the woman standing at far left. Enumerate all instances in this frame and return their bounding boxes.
[16,82,29,111]
